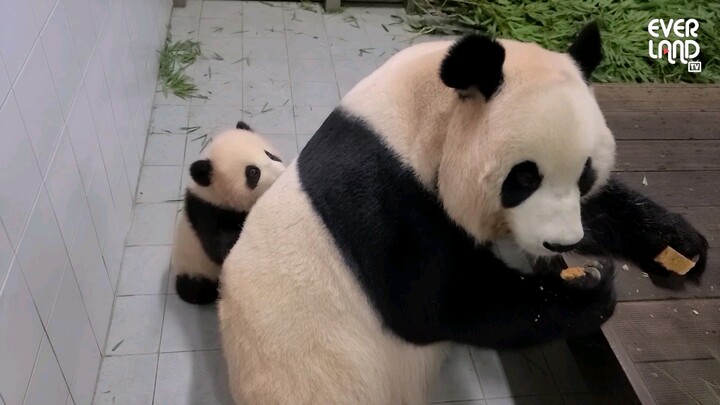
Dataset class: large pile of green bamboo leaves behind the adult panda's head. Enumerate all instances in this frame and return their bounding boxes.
[408,0,720,83]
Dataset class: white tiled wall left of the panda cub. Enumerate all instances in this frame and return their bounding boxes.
[0,0,171,405]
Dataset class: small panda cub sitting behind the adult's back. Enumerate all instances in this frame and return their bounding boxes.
[171,121,285,304]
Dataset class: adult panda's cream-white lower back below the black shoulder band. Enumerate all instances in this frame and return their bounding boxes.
[218,162,443,405]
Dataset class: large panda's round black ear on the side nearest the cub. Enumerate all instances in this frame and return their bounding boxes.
[440,34,505,99]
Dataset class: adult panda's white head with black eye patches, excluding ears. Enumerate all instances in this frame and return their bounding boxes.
[438,30,615,256]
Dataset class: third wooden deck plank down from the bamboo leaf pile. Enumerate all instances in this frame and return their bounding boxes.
[616,140,720,172]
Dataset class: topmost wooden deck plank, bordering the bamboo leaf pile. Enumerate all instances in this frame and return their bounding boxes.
[594,84,720,112]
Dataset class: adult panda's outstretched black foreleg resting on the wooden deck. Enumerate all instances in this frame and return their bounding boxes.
[577,177,708,274]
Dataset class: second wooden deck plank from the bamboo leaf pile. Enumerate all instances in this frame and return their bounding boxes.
[605,111,720,140]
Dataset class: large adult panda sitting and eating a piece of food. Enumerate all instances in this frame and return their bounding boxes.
[219,24,706,405]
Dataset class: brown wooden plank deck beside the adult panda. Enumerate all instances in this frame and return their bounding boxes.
[572,85,720,405]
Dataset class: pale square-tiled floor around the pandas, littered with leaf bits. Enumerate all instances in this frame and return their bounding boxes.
[91,0,604,405]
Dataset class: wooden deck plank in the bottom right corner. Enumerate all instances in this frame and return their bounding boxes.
[637,360,720,405]
